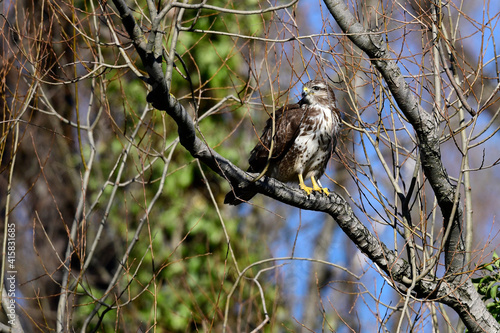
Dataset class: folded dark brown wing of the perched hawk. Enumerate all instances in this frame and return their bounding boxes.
[248,104,304,172]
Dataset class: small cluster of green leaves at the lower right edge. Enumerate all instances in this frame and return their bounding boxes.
[472,252,500,322]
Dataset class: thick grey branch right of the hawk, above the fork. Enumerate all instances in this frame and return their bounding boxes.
[325,0,464,273]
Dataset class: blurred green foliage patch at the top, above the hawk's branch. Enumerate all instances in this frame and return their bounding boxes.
[172,1,263,100]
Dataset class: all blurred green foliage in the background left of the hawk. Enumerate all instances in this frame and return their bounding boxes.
[16,0,292,332]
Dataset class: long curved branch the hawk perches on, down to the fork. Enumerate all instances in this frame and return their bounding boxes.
[109,0,410,284]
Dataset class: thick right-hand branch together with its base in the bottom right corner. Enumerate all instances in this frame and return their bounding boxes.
[324,0,500,332]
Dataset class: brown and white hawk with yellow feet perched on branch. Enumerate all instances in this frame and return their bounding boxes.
[224,80,341,206]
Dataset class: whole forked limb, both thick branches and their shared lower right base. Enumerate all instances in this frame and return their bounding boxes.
[107,0,500,332]
